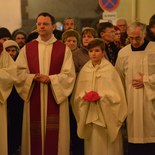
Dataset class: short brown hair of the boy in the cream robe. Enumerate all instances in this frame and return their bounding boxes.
[88,38,105,51]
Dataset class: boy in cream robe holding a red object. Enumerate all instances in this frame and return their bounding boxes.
[72,39,127,155]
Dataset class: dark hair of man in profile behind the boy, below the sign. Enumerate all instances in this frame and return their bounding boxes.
[97,22,114,37]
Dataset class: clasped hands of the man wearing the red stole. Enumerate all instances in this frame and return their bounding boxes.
[34,73,50,84]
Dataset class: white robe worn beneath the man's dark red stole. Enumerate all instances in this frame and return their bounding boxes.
[16,36,75,155]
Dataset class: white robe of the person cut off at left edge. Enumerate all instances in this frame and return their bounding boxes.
[0,51,17,155]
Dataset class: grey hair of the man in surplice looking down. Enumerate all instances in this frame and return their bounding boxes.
[127,22,146,34]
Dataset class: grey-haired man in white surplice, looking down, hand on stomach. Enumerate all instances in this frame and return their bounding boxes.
[116,22,155,155]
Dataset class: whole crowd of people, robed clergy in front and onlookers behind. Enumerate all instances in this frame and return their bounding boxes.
[0,12,155,155]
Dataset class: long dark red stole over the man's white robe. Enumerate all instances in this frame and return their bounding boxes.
[26,41,65,155]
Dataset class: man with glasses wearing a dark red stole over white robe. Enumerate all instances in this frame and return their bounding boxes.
[16,12,75,155]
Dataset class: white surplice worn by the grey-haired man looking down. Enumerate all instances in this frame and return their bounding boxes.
[116,42,155,143]
